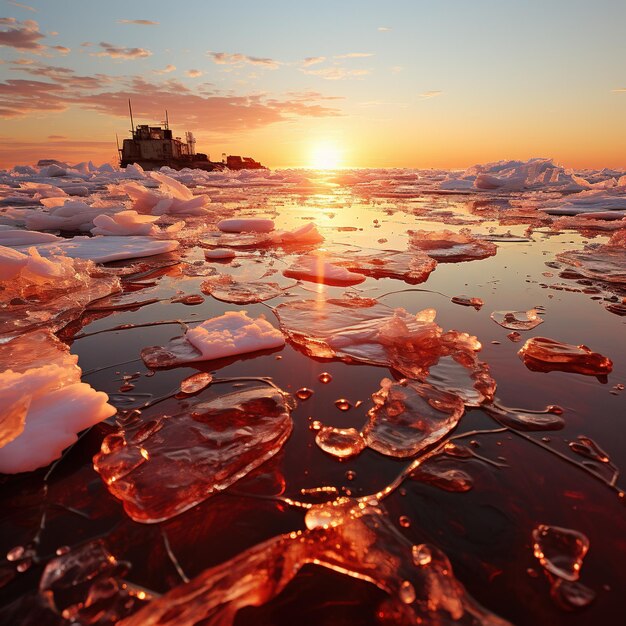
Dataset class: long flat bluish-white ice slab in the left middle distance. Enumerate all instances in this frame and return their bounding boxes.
[17,235,180,263]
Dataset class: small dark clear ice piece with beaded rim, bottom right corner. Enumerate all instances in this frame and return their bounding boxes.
[533,524,589,581]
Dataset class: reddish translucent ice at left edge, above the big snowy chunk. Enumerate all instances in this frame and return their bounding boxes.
[0,246,120,336]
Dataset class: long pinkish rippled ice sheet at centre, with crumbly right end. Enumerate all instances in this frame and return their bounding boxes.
[274,298,495,404]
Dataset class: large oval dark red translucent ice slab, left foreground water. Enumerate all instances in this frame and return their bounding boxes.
[94,386,292,523]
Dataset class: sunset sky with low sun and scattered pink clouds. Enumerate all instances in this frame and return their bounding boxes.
[0,0,626,168]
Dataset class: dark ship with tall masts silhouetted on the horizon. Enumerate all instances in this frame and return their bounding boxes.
[117,100,267,172]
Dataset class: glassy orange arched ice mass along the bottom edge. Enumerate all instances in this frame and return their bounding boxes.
[120,498,508,626]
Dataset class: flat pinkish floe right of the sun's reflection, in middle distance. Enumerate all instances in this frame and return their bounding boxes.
[409,229,498,263]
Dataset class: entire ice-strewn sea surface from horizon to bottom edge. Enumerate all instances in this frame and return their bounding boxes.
[0,159,626,626]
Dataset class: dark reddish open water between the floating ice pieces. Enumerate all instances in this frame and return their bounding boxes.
[0,168,626,626]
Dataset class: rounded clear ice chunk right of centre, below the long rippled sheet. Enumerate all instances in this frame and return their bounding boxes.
[363,378,465,458]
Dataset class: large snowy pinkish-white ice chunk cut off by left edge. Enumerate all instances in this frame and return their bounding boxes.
[0,331,115,474]
